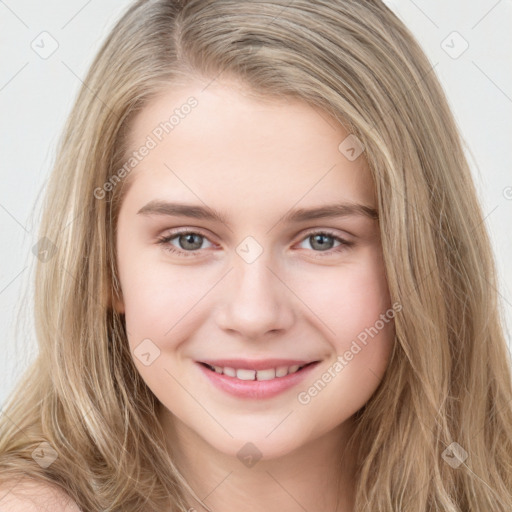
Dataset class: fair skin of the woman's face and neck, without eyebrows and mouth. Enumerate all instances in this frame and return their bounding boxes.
[115,81,394,512]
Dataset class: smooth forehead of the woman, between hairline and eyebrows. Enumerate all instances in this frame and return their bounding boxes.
[121,81,374,217]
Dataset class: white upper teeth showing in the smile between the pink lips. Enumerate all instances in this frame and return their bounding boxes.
[199,361,319,381]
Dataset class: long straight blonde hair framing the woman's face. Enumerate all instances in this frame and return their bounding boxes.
[0,0,512,512]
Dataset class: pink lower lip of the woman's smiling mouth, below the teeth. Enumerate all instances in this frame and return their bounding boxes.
[197,362,318,400]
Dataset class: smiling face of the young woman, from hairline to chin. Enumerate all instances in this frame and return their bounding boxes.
[115,78,394,458]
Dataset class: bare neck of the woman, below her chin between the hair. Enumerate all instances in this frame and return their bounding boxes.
[161,410,355,512]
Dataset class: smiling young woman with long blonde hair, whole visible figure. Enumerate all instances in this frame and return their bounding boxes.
[0,0,512,512]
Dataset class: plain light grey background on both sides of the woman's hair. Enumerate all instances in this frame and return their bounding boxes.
[0,0,512,404]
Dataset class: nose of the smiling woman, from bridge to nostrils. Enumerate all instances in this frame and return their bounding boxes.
[217,253,294,340]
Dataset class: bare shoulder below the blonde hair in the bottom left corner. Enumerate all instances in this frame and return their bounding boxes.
[0,478,80,512]
